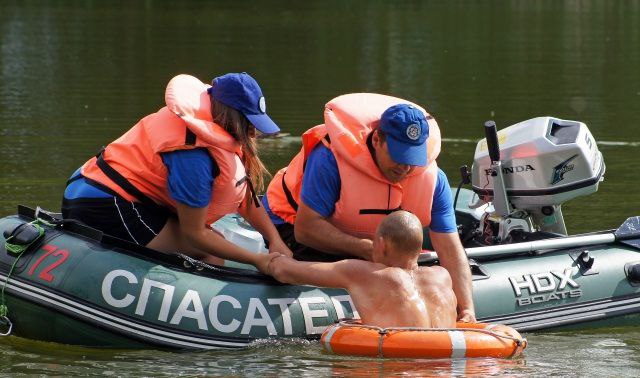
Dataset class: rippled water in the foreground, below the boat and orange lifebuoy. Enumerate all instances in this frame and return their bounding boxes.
[0,328,640,377]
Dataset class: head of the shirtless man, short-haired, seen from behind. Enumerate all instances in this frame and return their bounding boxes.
[373,210,422,261]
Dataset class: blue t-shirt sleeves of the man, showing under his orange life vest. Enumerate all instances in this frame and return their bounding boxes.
[262,144,458,233]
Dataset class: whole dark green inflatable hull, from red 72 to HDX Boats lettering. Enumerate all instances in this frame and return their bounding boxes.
[0,202,640,349]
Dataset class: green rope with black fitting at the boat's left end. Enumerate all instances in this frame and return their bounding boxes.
[0,218,48,336]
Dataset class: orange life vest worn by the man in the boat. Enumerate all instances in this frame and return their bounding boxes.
[267,93,440,238]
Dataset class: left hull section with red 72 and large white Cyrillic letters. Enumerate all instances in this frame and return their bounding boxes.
[0,208,354,349]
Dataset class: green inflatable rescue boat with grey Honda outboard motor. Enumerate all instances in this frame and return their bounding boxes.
[0,117,640,355]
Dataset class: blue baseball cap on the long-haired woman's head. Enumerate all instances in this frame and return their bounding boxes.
[207,72,280,134]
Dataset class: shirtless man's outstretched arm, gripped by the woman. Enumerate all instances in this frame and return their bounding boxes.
[268,255,373,289]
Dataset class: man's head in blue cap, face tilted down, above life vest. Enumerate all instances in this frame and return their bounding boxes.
[372,104,429,183]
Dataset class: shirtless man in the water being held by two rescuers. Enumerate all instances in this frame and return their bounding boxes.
[268,211,456,328]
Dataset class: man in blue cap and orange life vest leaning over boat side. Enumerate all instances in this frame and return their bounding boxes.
[263,93,475,321]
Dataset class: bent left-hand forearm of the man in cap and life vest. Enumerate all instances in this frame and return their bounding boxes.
[294,202,373,260]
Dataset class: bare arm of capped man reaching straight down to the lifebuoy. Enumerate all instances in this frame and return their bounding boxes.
[429,231,476,322]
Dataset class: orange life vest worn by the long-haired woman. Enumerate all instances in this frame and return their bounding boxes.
[82,75,247,224]
